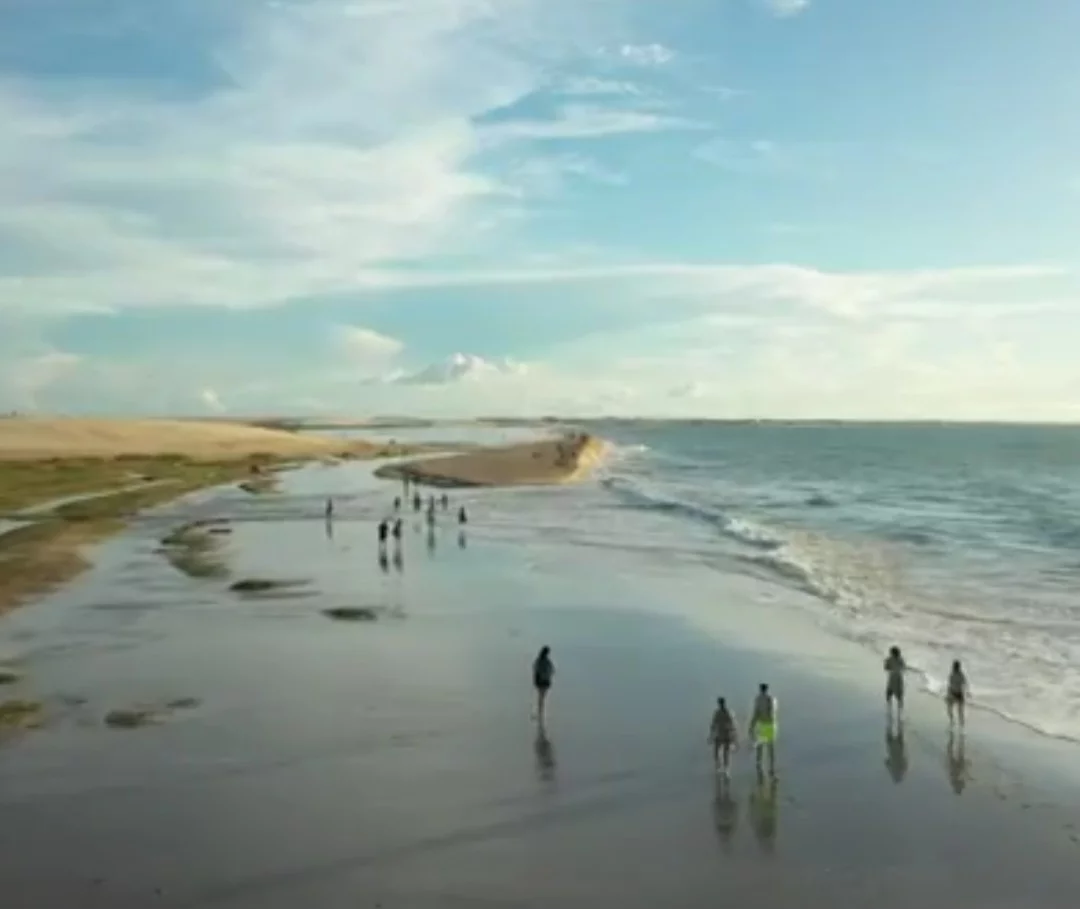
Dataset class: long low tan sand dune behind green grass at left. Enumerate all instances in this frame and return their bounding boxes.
[0,417,372,461]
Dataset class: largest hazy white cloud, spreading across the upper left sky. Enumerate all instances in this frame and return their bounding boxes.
[0,0,639,314]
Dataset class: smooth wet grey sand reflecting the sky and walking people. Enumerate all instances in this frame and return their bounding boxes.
[0,464,1080,909]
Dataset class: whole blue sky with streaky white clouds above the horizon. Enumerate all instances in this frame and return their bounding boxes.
[0,0,1080,420]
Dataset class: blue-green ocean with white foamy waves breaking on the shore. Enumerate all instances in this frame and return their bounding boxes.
[468,421,1080,741]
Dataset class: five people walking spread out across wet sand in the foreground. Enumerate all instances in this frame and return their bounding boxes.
[532,647,970,779]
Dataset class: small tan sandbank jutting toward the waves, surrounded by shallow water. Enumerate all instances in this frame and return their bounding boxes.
[376,434,606,486]
